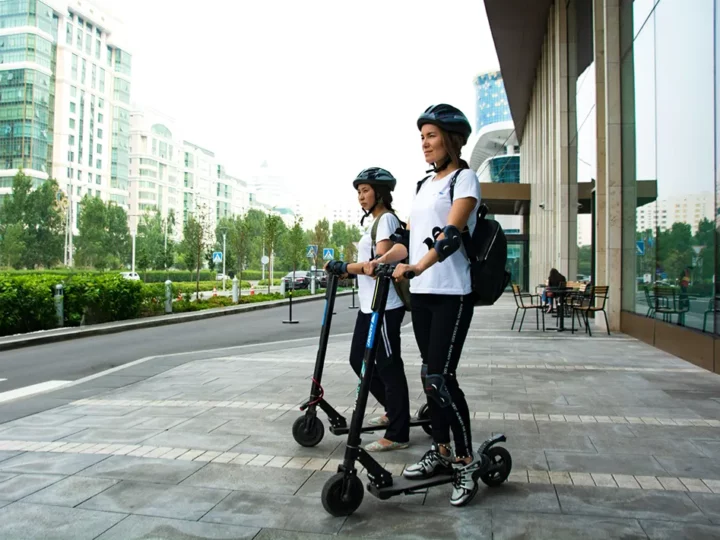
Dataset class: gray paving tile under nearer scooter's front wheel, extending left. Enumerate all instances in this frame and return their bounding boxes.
[201,492,345,534]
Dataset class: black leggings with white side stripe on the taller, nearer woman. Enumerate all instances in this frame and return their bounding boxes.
[412,294,473,457]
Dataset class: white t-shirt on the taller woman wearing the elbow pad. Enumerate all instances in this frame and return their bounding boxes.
[410,169,480,295]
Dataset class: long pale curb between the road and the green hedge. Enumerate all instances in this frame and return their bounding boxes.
[0,291,352,351]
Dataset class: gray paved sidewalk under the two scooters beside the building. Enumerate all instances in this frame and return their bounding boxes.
[0,301,720,540]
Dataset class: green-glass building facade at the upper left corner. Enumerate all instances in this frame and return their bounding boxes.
[0,0,57,181]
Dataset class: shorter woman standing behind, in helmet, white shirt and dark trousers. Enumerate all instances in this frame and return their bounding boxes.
[325,167,410,452]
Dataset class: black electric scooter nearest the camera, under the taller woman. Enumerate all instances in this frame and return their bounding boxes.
[322,265,512,517]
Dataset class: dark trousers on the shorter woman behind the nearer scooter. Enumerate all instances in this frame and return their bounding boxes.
[350,308,410,443]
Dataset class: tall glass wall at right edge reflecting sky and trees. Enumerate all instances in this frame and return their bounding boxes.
[620,0,720,334]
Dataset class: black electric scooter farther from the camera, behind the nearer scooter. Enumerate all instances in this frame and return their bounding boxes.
[292,272,432,447]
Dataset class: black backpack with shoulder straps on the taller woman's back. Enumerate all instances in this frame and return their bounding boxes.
[415,173,511,306]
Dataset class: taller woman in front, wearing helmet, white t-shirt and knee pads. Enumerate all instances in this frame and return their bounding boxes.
[378,104,488,506]
